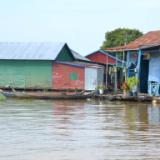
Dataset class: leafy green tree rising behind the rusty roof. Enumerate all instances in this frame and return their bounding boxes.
[101,28,143,49]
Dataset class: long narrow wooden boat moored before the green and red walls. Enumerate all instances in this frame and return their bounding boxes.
[1,91,92,99]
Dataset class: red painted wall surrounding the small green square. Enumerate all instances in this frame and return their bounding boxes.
[52,63,84,90]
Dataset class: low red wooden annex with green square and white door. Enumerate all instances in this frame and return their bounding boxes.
[52,61,104,90]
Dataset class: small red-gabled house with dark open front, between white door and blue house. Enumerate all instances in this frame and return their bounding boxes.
[86,49,124,89]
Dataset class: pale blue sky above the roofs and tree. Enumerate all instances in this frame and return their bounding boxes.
[0,0,160,55]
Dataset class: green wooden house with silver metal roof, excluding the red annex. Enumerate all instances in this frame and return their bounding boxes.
[0,42,88,89]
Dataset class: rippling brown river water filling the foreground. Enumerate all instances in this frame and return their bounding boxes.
[0,100,160,160]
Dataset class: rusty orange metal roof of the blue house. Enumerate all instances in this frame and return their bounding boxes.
[105,30,160,51]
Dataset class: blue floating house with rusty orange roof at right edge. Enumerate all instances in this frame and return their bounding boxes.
[107,31,160,96]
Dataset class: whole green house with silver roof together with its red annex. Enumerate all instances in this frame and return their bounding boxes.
[0,42,103,90]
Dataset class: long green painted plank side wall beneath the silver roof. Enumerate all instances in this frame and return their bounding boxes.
[0,60,52,88]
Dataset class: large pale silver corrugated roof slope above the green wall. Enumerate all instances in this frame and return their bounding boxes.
[0,42,66,60]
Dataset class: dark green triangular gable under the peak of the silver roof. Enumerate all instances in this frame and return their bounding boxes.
[56,46,74,62]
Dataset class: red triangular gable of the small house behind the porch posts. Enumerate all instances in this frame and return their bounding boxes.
[87,52,116,64]
